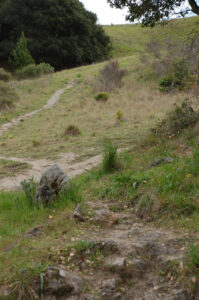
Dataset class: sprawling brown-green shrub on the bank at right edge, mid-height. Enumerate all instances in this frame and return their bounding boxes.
[152,102,199,136]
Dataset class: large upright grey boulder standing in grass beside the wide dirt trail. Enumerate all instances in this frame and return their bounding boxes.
[35,164,70,204]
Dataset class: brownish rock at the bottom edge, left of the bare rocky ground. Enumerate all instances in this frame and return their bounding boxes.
[44,267,83,297]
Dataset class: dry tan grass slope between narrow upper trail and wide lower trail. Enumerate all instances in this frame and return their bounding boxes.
[0,57,187,158]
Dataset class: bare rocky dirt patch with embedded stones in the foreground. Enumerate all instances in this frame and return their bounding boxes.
[4,197,194,300]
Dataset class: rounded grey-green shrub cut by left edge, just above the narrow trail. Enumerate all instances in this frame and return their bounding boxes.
[0,81,18,110]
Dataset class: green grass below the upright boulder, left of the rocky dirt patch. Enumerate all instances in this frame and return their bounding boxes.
[0,177,83,284]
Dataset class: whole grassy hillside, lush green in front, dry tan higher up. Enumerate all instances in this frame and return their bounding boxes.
[0,17,199,300]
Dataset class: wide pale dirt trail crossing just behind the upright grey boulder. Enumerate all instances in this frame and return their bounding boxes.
[0,152,102,191]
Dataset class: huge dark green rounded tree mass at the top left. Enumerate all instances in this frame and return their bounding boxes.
[0,0,111,69]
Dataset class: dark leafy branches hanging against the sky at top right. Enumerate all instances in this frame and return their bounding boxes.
[107,0,199,26]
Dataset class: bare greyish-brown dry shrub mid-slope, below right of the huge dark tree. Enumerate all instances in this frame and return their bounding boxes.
[93,60,126,92]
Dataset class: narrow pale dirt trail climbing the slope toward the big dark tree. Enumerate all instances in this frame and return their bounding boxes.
[0,80,75,136]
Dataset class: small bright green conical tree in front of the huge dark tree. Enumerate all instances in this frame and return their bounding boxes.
[11,32,34,69]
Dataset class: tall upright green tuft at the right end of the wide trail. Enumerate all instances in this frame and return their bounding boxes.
[102,139,119,173]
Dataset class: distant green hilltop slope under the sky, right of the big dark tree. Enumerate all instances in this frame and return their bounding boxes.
[104,17,199,57]
